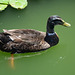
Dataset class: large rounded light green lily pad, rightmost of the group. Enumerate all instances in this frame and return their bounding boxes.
[9,0,28,9]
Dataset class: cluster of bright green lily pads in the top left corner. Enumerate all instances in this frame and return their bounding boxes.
[0,0,28,11]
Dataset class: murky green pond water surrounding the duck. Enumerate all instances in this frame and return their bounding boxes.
[0,0,75,75]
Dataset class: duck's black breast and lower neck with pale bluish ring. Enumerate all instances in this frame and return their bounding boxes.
[45,24,59,46]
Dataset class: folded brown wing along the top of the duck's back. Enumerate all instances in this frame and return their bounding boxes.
[3,29,46,43]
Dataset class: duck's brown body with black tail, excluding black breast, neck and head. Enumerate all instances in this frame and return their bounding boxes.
[0,29,50,53]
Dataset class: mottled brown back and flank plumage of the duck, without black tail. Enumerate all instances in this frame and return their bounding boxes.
[3,29,50,53]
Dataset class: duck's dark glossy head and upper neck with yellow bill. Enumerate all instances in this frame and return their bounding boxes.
[47,15,71,32]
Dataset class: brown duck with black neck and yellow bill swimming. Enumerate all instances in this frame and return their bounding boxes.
[0,15,71,54]
